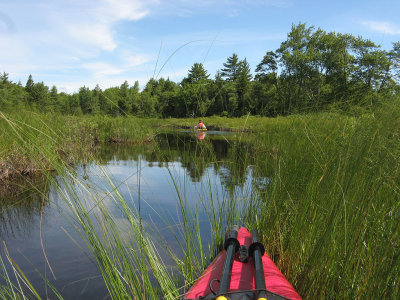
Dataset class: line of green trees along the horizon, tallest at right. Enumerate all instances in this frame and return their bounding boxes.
[0,23,400,118]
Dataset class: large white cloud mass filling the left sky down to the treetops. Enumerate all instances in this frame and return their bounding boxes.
[0,0,151,92]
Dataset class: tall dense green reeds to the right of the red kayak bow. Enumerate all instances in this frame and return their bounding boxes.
[247,102,400,299]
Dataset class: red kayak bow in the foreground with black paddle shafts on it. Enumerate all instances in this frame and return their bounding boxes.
[182,227,301,300]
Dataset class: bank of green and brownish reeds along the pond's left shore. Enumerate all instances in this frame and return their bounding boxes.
[0,111,154,182]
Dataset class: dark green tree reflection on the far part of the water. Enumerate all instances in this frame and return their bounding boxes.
[93,133,270,190]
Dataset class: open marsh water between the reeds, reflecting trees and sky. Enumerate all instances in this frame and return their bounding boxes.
[0,132,266,299]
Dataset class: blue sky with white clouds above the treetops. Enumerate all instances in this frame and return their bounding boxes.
[0,0,400,93]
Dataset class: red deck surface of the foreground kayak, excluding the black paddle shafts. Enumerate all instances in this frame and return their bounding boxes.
[183,227,301,300]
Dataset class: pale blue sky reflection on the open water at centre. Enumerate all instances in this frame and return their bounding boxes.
[81,160,227,229]
